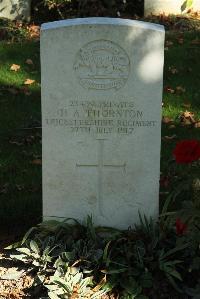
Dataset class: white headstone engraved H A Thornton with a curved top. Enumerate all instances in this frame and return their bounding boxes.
[41,18,164,228]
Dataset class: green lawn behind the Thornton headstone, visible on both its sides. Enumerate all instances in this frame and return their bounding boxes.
[0,26,200,230]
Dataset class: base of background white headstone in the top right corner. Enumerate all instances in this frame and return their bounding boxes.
[144,0,200,16]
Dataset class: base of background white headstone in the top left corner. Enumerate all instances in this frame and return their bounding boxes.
[0,0,31,20]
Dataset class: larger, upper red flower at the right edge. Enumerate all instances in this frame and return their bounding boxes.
[173,140,200,163]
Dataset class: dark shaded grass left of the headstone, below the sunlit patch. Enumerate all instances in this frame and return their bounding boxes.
[0,87,42,231]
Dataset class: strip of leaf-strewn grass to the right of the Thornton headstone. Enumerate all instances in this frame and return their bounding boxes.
[161,31,200,170]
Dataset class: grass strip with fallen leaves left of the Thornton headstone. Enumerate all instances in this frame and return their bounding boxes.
[0,42,42,229]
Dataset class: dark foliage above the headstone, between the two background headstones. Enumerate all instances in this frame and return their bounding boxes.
[32,0,144,22]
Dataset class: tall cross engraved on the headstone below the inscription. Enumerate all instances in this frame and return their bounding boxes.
[76,139,126,216]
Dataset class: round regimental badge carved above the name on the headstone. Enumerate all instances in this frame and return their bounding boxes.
[74,40,130,90]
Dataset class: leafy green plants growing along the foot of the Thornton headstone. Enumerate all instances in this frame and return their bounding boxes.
[5,214,200,299]
